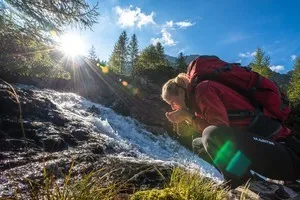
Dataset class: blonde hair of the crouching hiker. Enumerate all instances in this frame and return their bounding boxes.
[161,73,190,101]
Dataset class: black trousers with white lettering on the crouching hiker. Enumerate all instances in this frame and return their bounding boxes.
[196,126,300,188]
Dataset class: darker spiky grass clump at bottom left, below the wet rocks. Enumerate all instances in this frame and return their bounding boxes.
[28,164,129,200]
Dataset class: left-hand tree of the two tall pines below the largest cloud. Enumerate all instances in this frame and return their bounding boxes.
[109,31,128,74]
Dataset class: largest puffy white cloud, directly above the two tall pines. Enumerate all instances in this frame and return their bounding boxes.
[115,6,156,28]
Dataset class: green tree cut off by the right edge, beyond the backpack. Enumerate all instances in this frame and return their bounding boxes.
[288,56,300,102]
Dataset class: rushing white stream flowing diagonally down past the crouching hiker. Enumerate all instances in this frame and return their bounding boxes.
[17,85,223,182]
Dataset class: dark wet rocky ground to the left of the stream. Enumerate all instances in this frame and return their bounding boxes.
[0,85,176,197]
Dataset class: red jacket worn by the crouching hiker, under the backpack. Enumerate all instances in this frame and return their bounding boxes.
[188,81,291,139]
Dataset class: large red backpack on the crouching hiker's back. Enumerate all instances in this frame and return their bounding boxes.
[187,56,291,122]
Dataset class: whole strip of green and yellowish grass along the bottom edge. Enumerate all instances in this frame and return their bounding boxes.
[15,164,228,200]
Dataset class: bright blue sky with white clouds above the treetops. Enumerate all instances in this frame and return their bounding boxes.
[72,0,300,73]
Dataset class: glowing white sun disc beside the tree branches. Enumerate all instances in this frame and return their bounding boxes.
[61,35,84,56]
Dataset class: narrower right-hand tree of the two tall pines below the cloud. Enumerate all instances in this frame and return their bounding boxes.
[128,34,139,74]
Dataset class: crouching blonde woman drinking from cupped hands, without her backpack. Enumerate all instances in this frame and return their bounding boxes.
[162,74,300,188]
